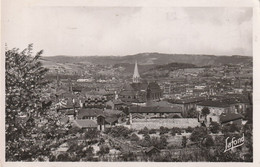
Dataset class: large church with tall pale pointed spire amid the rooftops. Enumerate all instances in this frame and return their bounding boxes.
[119,62,162,103]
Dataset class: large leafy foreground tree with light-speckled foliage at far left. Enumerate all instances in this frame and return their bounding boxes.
[5,45,67,161]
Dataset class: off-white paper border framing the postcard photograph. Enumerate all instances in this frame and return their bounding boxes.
[0,0,260,167]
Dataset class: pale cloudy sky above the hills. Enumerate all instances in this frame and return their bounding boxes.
[3,6,252,56]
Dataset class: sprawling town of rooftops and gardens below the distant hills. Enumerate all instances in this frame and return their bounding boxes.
[9,53,250,162]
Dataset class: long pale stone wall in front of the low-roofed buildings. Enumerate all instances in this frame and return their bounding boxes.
[131,118,200,130]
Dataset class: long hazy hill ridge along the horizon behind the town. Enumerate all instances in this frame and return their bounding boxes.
[42,53,252,66]
